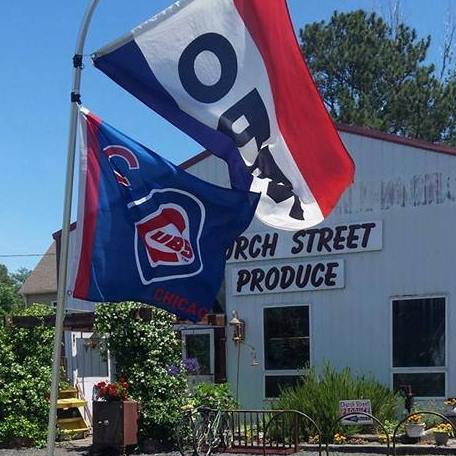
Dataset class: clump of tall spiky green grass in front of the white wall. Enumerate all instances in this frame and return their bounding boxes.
[273,365,400,440]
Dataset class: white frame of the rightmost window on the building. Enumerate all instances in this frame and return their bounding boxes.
[389,293,449,401]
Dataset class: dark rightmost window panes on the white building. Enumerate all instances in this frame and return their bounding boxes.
[392,297,446,397]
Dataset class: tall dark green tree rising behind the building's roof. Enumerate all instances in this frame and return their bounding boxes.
[300,10,456,143]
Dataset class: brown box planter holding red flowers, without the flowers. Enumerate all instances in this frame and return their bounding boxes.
[93,401,138,450]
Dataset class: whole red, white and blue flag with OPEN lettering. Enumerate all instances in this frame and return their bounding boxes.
[93,0,354,230]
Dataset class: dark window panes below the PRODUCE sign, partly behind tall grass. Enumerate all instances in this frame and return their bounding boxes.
[263,306,310,398]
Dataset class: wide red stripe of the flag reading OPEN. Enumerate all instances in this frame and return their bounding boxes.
[233,0,355,216]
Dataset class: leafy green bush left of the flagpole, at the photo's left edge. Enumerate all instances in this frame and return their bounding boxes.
[0,304,54,446]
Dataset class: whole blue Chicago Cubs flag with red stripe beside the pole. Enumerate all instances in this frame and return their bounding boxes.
[72,106,259,321]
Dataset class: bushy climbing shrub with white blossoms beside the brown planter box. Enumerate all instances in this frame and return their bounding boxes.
[95,302,188,444]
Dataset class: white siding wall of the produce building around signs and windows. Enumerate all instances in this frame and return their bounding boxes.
[189,134,456,408]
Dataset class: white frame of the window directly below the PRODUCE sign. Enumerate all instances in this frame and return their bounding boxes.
[261,303,313,402]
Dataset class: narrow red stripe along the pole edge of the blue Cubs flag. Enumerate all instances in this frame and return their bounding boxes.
[73,113,101,299]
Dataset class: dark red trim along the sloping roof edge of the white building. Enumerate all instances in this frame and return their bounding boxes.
[179,123,456,169]
